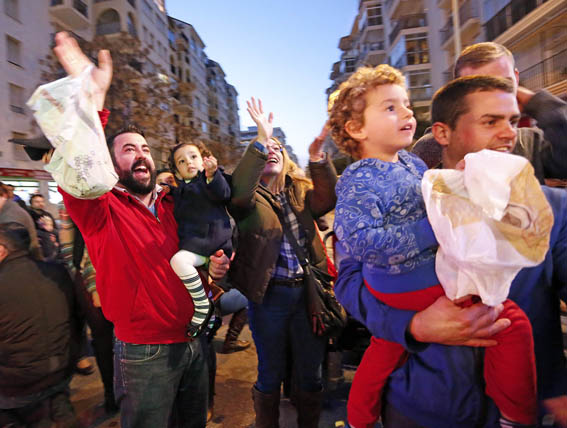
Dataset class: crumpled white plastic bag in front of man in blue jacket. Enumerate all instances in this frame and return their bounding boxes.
[421,150,553,306]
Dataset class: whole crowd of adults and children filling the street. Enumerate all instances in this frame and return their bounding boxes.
[0,28,567,428]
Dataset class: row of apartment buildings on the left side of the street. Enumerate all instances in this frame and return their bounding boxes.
[0,0,240,202]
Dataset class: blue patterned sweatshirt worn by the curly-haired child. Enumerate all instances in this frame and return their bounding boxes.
[334,150,439,293]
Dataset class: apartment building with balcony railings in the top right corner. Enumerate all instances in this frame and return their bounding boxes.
[436,0,567,99]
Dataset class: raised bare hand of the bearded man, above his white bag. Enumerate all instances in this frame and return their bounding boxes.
[53,32,112,110]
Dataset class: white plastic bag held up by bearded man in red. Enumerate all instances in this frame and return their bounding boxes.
[27,66,118,199]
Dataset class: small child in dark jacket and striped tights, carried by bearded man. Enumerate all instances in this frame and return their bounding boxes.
[170,141,232,337]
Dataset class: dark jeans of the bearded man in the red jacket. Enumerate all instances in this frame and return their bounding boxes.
[114,339,208,428]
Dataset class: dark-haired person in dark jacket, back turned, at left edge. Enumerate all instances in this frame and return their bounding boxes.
[0,222,78,427]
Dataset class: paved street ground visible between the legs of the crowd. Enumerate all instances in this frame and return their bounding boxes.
[71,319,354,428]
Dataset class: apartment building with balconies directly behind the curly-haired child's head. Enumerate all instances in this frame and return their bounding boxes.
[327,0,446,145]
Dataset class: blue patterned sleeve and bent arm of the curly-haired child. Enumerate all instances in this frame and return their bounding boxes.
[335,168,437,266]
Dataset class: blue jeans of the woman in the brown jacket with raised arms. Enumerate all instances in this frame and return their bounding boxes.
[248,286,326,394]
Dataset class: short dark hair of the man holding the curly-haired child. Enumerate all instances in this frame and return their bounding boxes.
[431,76,515,129]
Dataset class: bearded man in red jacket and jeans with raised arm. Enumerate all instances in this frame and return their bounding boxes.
[36,33,228,428]
